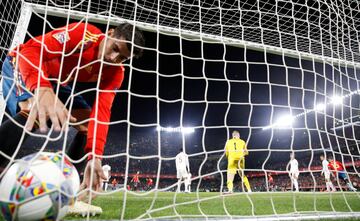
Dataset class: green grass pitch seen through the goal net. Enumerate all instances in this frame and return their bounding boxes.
[65,192,360,220]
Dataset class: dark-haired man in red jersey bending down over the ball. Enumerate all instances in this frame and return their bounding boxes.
[0,22,145,201]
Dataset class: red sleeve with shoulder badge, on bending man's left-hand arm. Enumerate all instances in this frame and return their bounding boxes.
[15,23,94,91]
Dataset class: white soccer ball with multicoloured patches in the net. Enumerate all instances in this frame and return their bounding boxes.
[0,152,80,220]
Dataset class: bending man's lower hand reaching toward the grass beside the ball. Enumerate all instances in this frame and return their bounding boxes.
[79,158,106,200]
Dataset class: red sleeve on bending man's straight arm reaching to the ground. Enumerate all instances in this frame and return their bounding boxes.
[85,66,124,159]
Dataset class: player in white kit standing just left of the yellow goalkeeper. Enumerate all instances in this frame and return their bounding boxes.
[175,150,191,193]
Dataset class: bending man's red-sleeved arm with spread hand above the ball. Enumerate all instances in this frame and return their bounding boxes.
[17,23,93,132]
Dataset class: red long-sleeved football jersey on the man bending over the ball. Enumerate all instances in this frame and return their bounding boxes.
[9,23,124,155]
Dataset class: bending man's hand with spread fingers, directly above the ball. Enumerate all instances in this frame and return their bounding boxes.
[26,87,76,133]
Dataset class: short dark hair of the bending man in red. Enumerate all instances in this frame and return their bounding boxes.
[114,23,145,58]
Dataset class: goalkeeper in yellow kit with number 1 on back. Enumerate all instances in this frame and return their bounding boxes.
[225,130,251,193]
